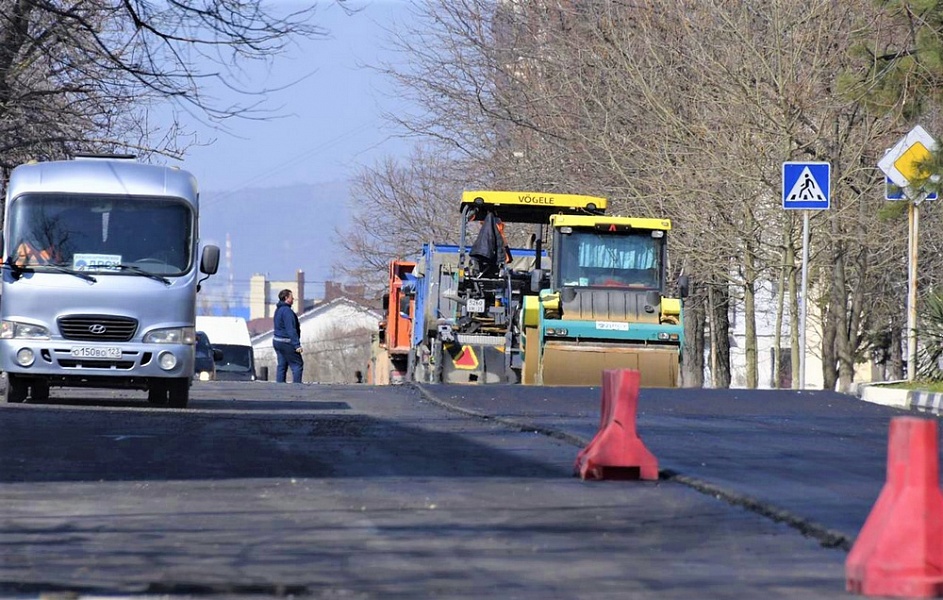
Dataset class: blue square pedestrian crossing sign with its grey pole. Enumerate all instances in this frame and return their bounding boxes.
[783,162,832,390]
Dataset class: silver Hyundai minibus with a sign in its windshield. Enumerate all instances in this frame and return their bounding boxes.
[0,156,219,408]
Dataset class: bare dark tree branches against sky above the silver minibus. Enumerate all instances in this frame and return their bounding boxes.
[0,0,338,169]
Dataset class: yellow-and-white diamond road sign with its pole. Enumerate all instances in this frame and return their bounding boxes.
[878,125,937,381]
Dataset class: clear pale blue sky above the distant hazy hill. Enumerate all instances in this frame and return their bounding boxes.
[182,0,408,193]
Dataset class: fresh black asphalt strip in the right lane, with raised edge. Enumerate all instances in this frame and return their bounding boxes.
[423,386,916,547]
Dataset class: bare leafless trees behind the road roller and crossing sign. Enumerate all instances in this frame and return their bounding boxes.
[362,0,938,390]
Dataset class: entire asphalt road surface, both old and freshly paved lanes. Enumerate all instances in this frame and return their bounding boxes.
[0,382,916,598]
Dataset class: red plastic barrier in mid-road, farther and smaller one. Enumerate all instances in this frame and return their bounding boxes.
[574,369,658,479]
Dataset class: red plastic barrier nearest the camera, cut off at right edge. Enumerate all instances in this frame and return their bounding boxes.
[845,417,943,598]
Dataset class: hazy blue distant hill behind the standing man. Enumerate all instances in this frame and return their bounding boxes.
[200,181,350,295]
